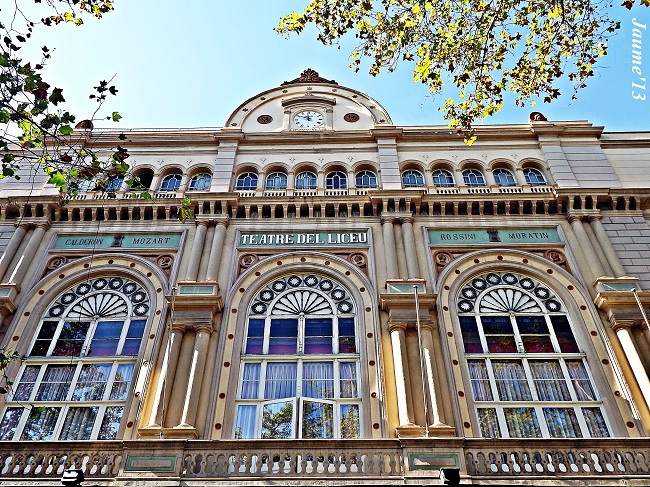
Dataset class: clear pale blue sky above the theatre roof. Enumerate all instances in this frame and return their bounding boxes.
[25,0,650,131]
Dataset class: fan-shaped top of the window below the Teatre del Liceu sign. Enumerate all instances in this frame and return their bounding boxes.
[251,274,354,315]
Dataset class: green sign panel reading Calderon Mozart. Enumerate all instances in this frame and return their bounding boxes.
[52,233,181,250]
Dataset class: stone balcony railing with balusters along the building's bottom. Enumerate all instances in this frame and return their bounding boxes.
[0,438,650,486]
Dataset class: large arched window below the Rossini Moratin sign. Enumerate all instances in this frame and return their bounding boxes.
[457,272,610,438]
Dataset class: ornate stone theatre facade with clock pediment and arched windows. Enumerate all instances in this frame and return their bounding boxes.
[0,70,650,486]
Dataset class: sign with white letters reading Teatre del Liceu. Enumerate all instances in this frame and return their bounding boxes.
[239,230,368,247]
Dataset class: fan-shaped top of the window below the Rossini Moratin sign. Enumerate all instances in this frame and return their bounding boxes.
[458,272,564,313]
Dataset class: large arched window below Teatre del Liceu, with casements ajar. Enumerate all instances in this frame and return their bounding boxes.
[233,274,362,438]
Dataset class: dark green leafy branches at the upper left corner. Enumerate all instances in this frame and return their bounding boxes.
[0,0,150,199]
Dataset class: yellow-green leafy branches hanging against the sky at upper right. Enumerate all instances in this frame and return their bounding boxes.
[276,0,650,143]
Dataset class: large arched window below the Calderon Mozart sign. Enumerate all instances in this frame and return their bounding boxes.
[0,276,151,440]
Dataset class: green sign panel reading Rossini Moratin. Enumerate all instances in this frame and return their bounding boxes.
[429,228,562,245]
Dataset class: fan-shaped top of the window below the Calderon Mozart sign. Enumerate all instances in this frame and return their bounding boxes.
[48,277,150,319]
